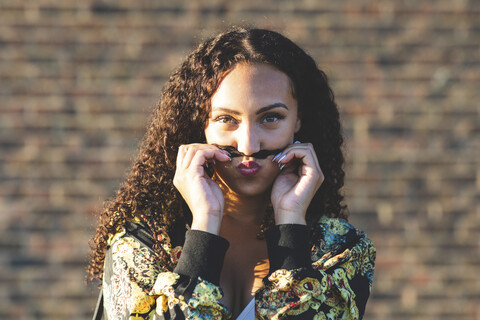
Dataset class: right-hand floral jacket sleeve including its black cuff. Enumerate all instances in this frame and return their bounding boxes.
[255,217,375,319]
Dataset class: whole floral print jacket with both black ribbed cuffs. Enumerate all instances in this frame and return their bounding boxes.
[103,216,375,320]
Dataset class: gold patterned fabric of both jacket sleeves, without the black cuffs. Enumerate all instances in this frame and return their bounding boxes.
[103,217,375,319]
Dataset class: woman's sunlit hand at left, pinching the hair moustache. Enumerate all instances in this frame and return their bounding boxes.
[173,143,231,235]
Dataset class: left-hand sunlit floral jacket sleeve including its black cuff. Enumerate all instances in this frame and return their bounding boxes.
[103,231,230,319]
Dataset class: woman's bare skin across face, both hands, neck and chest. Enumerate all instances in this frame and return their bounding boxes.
[174,64,324,315]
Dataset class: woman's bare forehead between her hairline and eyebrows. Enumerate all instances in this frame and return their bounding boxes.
[211,63,296,109]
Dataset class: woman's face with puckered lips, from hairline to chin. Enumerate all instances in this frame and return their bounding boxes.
[205,63,300,196]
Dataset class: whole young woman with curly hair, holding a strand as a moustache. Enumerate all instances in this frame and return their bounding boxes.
[88,28,375,319]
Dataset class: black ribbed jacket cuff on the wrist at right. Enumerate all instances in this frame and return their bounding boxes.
[265,224,312,273]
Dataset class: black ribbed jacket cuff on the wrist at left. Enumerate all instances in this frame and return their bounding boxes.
[173,230,229,285]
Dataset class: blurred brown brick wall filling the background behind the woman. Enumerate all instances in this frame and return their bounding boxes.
[0,0,480,319]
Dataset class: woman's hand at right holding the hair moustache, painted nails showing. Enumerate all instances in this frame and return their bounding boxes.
[271,143,324,224]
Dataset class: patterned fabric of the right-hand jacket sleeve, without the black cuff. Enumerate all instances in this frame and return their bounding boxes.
[255,217,376,319]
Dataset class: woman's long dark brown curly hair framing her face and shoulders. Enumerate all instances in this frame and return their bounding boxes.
[87,28,347,279]
